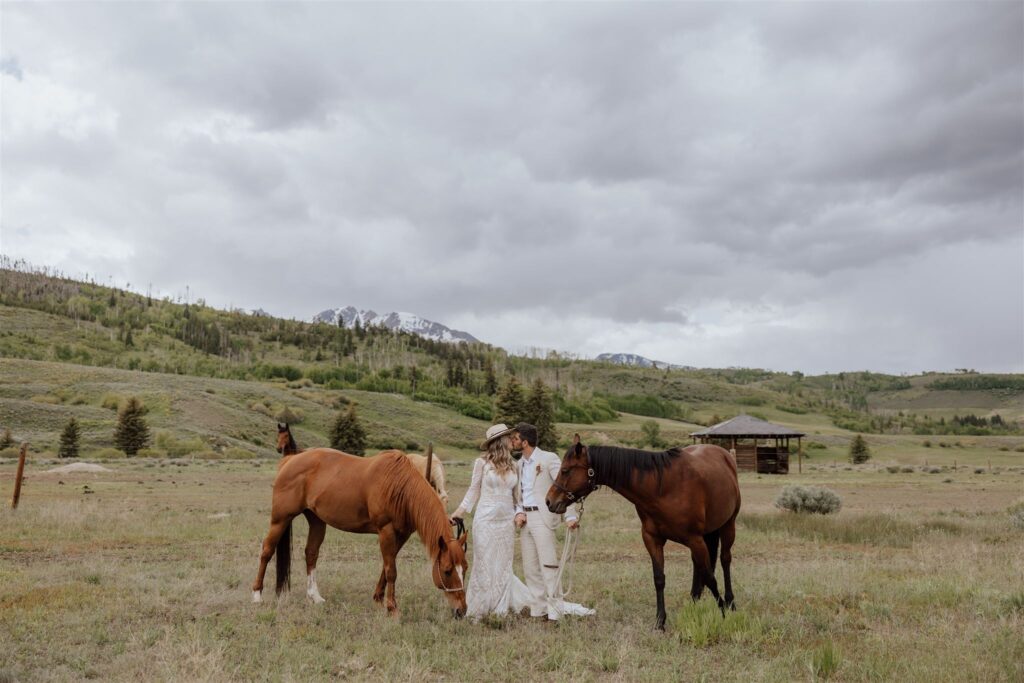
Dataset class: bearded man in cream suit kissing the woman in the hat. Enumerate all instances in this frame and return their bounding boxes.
[512,422,580,622]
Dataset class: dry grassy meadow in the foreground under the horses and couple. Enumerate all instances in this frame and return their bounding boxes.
[0,448,1024,681]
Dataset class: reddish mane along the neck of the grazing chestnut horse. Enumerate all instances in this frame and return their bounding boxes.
[379,451,452,557]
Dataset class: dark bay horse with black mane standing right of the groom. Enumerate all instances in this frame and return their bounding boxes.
[545,434,739,631]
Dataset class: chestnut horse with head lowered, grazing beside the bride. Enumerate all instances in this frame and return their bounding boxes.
[252,449,467,617]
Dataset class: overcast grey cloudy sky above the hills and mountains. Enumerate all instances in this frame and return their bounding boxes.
[0,2,1024,373]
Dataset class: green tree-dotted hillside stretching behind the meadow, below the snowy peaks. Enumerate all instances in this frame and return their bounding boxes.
[0,262,1024,456]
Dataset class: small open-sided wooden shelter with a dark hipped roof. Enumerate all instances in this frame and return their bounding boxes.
[690,415,806,474]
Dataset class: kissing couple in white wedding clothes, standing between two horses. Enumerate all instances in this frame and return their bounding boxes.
[452,423,594,621]
